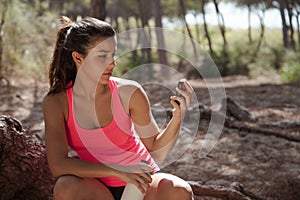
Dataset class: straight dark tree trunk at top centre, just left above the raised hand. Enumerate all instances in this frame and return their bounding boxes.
[152,0,168,65]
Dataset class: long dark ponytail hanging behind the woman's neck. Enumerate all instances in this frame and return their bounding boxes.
[48,16,76,94]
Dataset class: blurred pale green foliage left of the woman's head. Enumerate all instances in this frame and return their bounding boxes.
[3,0,58,78]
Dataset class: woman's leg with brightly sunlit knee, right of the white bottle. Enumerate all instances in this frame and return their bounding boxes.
[144,173,194,200]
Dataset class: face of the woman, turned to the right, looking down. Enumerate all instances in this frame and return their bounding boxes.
[77,37,117,84]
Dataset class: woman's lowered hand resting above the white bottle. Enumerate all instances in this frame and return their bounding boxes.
[113,163,154,194]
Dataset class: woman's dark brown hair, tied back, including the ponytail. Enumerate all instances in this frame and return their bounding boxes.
[48,17,116,95]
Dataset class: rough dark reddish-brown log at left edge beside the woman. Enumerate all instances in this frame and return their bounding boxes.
[0,116,54,200]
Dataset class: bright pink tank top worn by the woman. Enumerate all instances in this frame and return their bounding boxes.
[66,79,159,187]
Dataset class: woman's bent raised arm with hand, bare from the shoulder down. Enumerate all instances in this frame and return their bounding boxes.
[129,82,193,162]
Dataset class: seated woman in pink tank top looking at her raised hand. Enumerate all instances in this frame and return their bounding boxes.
[44,17,193,200]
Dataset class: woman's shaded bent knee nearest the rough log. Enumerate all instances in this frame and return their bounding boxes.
[53,176,81,200]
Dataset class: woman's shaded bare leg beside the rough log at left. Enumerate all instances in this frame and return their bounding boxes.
[53,175,114,200]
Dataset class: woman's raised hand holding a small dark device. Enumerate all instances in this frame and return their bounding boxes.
[171,81,194,118]
